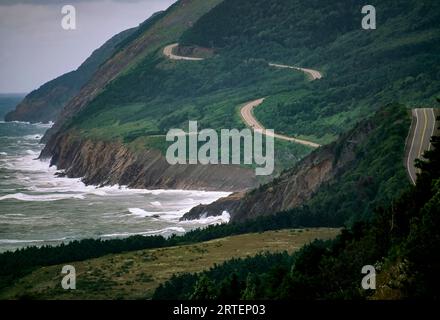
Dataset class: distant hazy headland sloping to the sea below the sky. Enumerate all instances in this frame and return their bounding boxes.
[5,28,137,122]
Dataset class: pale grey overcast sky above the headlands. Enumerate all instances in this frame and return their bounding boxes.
[0,0,176,93]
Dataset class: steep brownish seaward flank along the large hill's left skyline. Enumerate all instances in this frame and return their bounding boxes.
[42,0,221,148]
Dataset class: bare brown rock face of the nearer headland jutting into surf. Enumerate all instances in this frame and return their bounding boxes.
[182,121,374,221]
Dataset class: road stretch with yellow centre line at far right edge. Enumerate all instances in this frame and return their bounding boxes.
[406,108,436,184]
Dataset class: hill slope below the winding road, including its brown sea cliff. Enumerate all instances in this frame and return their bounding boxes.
[42,0,309,191]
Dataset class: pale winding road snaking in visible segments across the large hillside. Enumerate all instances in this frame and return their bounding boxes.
[163,43,322,148]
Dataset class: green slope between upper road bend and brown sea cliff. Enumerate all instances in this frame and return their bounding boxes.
[70,50,311,170]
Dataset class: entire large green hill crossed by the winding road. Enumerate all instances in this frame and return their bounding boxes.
[42,0,440,190]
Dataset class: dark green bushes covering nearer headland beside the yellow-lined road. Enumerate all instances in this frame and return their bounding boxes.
[243,104,411,226]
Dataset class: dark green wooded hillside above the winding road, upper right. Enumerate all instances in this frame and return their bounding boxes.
[181,0,440,143]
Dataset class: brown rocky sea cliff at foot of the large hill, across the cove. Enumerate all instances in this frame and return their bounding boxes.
[52,134,257,191]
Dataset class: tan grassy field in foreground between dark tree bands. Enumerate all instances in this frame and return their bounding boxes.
[0,229,339,299]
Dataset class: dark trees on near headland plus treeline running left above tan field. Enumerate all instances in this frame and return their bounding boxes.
[0,105,409,287]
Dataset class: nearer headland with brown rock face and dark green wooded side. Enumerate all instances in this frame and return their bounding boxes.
[182,105,409,221]
